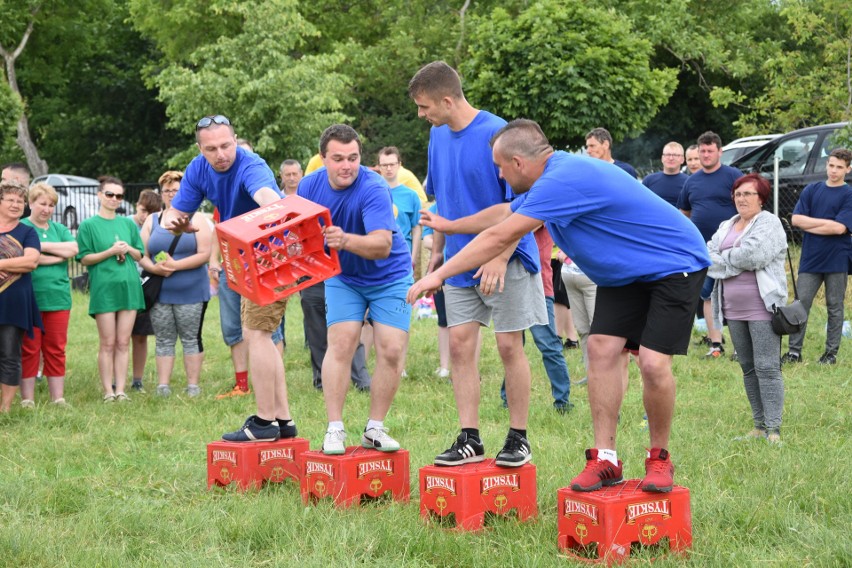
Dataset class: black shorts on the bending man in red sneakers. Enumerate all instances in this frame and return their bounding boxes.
[590,269,707,355]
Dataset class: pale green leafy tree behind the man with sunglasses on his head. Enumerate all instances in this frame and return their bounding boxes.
[130,0,351,167]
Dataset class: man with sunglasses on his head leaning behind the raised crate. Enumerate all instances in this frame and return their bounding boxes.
[163,114,296,442]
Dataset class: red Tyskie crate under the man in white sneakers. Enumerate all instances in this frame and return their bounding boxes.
[300,446,411,507]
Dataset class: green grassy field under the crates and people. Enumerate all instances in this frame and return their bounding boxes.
[0,280,852,568]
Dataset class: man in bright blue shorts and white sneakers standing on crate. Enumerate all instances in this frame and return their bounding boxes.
[296,124,413,455]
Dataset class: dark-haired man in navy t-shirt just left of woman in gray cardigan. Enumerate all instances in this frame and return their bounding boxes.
[677,131,743,359]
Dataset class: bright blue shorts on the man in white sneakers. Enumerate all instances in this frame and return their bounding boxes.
[325,274,414,331]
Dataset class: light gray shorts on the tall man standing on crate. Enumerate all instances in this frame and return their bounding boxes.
[444,259,548,333]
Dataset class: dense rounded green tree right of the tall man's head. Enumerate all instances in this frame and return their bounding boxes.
[461,0,676,147]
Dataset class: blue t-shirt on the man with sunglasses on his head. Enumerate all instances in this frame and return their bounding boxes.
[172,147,284,221]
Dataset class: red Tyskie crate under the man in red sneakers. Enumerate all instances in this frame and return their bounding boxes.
[556,479,692,563]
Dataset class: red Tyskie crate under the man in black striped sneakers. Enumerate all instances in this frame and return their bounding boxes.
[420,459,538,531]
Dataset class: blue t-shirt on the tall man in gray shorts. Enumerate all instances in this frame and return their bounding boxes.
[426,110,539,288]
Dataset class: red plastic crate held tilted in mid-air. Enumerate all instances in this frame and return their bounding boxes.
[216,195,340,306]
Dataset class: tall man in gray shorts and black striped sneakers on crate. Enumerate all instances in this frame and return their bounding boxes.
[408,61,548,467]
